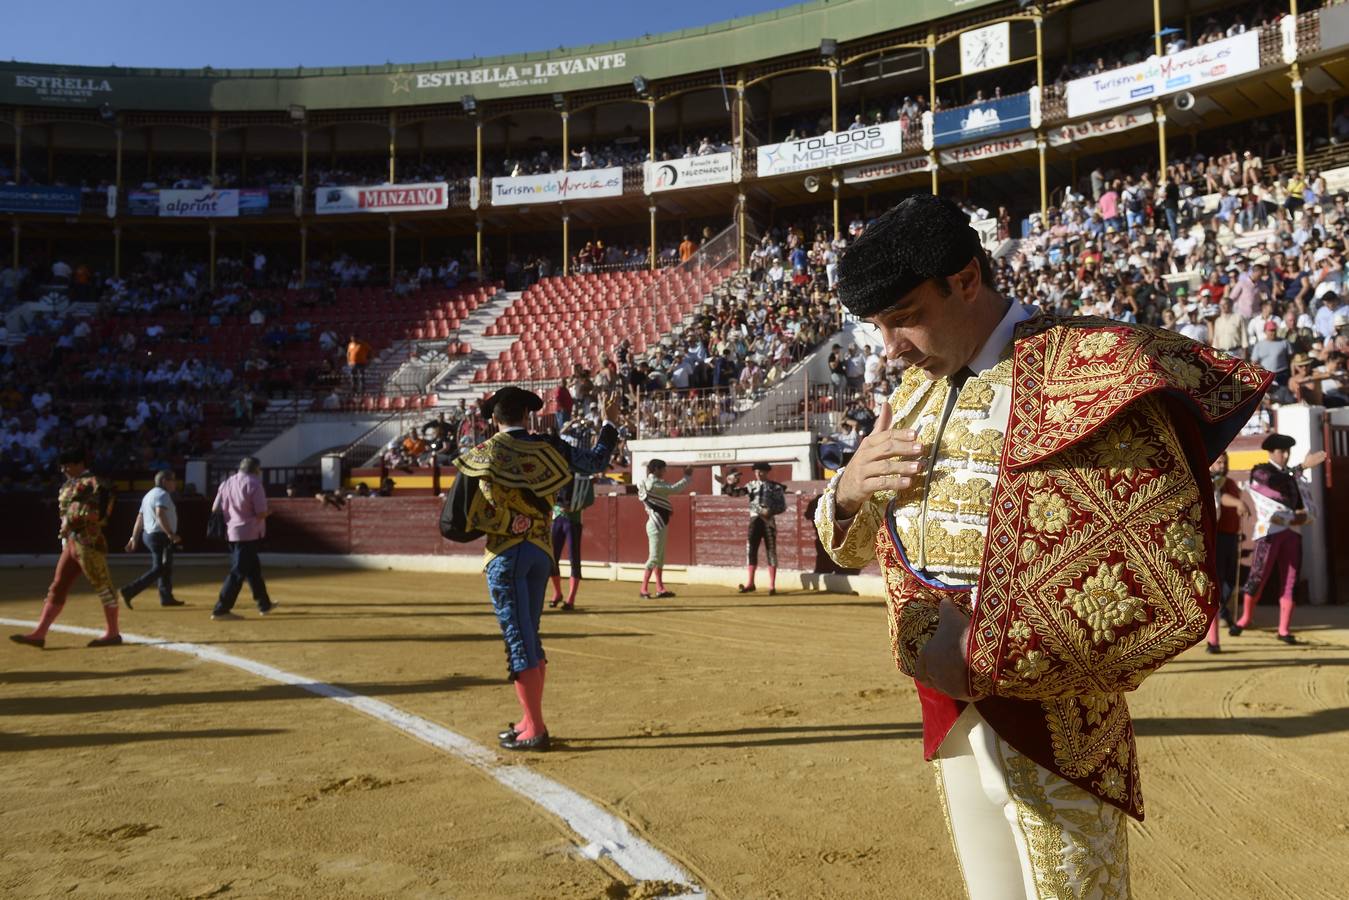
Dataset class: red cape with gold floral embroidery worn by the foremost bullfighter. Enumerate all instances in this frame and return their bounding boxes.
[816,316,1271,819]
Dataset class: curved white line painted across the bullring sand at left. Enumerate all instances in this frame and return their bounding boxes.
[0,618,707,900]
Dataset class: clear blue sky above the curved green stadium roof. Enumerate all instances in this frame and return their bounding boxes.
[0,0,795,69]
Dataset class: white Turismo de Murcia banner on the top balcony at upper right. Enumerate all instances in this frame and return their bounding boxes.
[1067,31,1260,119]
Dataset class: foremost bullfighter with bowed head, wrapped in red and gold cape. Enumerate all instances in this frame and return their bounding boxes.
[816,196,1269,899]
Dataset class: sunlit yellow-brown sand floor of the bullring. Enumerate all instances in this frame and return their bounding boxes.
[0,567,1349,900]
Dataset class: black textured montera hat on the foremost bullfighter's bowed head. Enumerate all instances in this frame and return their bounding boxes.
[838,194,983,318]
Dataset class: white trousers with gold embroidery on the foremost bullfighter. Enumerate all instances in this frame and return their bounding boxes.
[934,704,1129,900]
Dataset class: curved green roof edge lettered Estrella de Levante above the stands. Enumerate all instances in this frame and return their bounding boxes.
[0,0,1001,111]
